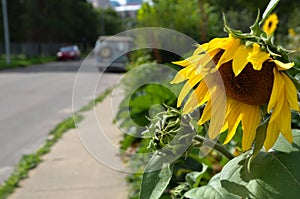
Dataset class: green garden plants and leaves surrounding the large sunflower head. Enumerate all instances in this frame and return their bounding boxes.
[116,0,300,199]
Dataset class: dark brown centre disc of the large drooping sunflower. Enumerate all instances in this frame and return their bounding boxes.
[214,53,274,105]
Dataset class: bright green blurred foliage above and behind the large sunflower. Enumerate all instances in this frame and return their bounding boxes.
[137,0,300,43]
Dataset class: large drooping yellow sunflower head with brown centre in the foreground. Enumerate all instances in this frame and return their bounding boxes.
[171,35,299,151]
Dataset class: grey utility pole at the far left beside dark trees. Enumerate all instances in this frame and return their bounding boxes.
[2,0,10,64]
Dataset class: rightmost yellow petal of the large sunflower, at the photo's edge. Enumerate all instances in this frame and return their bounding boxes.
[282,74,299,111]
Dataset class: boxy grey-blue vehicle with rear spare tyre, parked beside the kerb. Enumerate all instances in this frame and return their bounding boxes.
[94,36,133,71]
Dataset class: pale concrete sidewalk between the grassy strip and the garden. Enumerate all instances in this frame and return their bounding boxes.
[9,92,127,199]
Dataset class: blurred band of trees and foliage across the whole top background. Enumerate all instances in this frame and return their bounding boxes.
[0,0,300,53]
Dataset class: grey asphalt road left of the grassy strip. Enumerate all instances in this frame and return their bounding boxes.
[0,60,121,184]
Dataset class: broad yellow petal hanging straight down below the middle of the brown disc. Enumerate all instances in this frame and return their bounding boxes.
[241,103,260,151]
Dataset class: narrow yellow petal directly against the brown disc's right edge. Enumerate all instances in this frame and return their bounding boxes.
[268,68,284,113]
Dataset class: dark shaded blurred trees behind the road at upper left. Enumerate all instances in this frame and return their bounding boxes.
[0,0,124,47]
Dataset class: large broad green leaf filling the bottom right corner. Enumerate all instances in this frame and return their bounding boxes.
[217,130,300,198]
